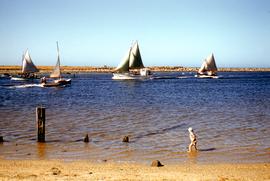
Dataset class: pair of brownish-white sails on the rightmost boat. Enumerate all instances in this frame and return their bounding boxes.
[198,53,217,75]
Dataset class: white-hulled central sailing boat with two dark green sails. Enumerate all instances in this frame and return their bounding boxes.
[112,41,151,80]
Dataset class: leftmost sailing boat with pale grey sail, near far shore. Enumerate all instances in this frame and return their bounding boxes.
[11,49,39,80]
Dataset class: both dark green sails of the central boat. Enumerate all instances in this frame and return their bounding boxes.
[115,41,144,73]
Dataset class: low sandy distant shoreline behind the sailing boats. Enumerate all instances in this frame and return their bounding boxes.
[0,65,270,74]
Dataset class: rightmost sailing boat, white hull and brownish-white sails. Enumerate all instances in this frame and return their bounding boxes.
[195,53,218,78]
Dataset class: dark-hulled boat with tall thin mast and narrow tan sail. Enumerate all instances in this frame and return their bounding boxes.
[42,42,71,87]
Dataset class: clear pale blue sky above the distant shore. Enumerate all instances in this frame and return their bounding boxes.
[0,0,270,67]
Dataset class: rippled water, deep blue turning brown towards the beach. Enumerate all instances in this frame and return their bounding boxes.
[0,72,270,164]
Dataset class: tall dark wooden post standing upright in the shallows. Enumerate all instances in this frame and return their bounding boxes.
[36,107,45,142]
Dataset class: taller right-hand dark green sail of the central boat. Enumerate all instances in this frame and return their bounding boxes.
[129,41,144,69]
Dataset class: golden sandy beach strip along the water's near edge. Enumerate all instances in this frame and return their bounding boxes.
[0,160,270,181]
